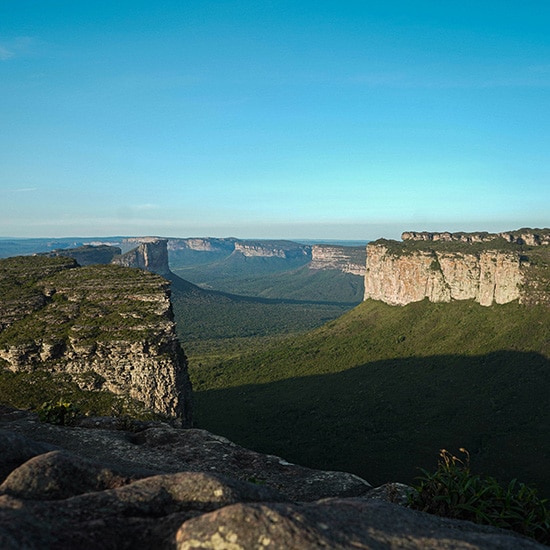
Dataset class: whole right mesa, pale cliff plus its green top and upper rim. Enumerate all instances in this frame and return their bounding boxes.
[365,230,550,306]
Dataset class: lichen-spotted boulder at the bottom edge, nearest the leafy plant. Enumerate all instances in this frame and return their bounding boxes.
[176,498,545,550]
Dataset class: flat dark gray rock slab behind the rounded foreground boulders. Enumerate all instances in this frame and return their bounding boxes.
[0,410,371,501]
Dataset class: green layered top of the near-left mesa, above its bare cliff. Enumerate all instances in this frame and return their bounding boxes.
[0,264,167,346]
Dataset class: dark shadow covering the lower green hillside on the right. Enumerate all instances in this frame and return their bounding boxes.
[195,351,550,497]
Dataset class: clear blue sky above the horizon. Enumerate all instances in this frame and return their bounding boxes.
[0,0,550,239]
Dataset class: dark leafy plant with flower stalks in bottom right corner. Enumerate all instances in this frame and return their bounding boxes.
[409,449,550,544]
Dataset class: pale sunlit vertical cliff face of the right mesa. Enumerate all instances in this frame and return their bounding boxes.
[365,239,528,306]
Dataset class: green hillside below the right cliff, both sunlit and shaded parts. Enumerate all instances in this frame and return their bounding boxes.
[190,301,550,495]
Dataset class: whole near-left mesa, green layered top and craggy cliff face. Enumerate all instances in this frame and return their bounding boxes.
[0,256,191,425]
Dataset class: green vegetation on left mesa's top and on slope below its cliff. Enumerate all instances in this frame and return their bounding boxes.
[0,256,177,422]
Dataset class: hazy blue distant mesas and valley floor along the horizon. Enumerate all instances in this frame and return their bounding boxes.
[0,236,366,305]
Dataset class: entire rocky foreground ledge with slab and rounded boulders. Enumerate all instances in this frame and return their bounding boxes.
[0,407,545,550]
